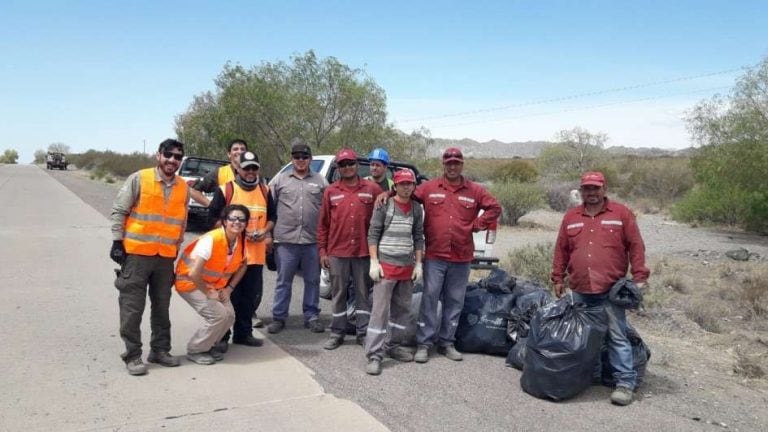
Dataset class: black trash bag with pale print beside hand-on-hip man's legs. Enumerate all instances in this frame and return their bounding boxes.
[456,285,515,355]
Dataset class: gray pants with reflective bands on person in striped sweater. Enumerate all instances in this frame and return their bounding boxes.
[365,279,413,360]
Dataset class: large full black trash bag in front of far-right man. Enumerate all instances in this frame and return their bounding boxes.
[520,296,608,401]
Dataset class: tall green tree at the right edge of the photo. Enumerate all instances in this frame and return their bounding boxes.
[674,58,768,233]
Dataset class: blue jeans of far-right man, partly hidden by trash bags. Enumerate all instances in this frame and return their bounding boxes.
[573,292,637,390]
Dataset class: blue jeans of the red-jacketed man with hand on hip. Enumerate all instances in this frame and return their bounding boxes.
[416,259,469,347]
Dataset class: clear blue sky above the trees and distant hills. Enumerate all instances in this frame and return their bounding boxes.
[0,0,768,163]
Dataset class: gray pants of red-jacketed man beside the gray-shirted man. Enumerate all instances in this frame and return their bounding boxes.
[329,257,373,337]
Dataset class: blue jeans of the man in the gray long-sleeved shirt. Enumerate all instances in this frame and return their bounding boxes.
[272,243,320,323]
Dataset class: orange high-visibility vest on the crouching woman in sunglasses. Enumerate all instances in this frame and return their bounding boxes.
[176,228,245,292]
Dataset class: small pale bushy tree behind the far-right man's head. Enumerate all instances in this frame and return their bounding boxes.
[538,127,608,180]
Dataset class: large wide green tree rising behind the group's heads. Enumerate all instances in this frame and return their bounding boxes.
[176,51,404,172]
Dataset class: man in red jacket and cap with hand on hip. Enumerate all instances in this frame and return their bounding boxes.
[414,147,501,363]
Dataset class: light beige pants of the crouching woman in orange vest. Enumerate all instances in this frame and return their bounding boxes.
[179,289,235,354]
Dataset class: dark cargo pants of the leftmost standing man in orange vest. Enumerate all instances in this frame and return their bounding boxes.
[115,254,174,362]
